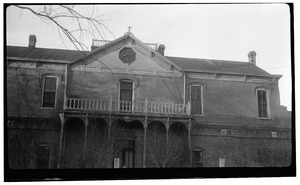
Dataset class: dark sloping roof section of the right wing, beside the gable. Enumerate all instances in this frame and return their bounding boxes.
[166,56,270,76]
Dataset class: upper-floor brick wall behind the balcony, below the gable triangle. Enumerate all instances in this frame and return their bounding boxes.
[67,71,183,104]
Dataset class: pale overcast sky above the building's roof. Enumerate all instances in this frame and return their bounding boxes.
[6,4,291,110]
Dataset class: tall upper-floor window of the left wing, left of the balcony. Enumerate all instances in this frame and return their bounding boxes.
[42,77,57,108]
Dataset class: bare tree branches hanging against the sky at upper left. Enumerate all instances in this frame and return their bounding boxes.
[14,5,114,51]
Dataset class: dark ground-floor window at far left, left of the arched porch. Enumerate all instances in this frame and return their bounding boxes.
[36,145,51,169]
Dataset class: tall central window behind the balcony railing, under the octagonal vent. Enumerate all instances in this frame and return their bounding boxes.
[120,81,133,111]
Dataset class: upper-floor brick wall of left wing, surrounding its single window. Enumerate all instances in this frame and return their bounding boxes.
[6,62,65,117]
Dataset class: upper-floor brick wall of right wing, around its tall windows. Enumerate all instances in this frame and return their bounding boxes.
[186,79,290,127]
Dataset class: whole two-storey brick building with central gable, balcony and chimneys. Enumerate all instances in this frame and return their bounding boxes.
[6,32,292,169]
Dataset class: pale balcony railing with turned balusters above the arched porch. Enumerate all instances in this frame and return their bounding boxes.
[65,98,190,115]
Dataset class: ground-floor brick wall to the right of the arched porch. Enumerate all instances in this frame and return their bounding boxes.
[192,129,291,167]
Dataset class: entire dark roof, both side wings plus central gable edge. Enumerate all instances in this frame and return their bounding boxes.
[7,35,270,76]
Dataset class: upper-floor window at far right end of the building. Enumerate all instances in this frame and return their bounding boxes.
[257,89,269,118]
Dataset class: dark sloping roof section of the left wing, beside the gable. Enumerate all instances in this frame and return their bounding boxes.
[7,46,88,62]
